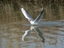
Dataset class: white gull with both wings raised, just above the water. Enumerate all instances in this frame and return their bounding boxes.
[21,8,44,25]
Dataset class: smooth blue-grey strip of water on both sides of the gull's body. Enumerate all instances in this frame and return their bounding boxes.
[23,21,64,26]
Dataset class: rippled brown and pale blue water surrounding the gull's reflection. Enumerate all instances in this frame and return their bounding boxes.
[0,21,64,48]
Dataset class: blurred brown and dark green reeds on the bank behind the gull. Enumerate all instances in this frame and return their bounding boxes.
[0,0,64,24]
